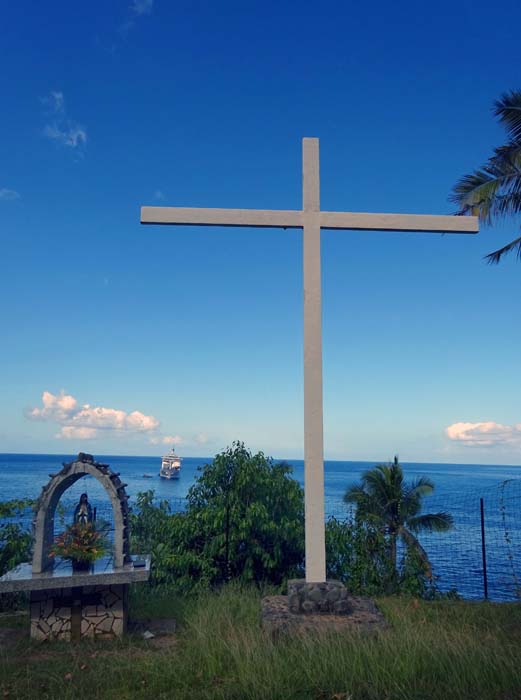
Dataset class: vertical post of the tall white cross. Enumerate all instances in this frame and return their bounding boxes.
[302,138,326,582]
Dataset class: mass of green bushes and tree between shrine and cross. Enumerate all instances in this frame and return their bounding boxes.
[131,442,304,591]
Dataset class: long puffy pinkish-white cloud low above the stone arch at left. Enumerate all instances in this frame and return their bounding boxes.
[26,391,160,439]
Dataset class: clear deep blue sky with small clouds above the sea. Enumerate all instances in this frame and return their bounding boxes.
[0,0,521,464]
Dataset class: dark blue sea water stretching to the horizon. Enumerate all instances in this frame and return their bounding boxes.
[0,454,521,600]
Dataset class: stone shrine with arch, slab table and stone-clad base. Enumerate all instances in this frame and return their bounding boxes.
[0,452,150,641]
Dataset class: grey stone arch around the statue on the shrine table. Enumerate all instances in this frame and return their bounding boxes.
[33,452,130,574]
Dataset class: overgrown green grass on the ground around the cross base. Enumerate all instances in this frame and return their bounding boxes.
[0,587,521,700]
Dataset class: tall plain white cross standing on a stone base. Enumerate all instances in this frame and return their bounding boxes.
[141,138,478,582]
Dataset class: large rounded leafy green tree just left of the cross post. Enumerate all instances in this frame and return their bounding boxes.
[187,442,304,584]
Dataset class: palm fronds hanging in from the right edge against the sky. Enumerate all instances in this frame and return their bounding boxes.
[450,90,521,263]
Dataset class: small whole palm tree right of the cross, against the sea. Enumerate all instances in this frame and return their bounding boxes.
[344,456,453,575]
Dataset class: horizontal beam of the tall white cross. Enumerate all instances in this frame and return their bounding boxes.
[141,207,478,233]
